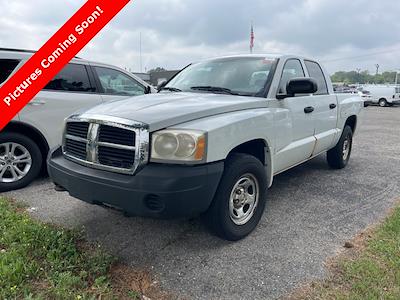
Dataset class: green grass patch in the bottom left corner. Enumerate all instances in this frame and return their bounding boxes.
[0,197,159,300]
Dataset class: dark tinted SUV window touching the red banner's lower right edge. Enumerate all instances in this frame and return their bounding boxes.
[44,64,95,93]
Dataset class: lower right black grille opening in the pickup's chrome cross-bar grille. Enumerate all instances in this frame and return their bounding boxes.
[98,146,135,169]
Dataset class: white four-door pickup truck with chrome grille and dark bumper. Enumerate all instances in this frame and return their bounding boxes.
[48,55,363,241]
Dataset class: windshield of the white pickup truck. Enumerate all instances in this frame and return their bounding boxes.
[165,57,276,96]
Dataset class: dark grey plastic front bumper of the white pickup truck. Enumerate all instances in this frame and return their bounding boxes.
[48,148,224,219]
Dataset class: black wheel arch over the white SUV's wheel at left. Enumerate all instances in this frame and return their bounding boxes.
[0,121,50,171]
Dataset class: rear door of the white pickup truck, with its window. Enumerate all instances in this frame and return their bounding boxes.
[304,60,338,155]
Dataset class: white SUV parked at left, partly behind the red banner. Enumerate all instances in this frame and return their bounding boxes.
[0,49,155,192]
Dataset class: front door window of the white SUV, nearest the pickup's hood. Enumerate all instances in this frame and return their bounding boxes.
[91,66,146,101]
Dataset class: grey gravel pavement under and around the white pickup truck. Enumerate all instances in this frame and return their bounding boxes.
[3,107,400,299]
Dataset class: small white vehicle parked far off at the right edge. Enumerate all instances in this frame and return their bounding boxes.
[362,85,400,107]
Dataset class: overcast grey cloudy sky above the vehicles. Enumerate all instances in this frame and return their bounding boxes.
[0,0,400,73]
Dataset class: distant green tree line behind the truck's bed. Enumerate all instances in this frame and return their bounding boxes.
[331,71,400,84]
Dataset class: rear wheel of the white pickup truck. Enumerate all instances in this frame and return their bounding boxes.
[327,125,353,169]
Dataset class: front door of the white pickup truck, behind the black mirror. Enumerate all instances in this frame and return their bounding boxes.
[274,59,315,173]
